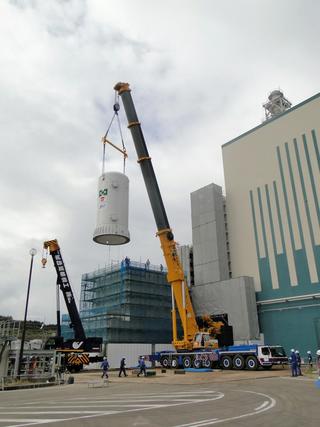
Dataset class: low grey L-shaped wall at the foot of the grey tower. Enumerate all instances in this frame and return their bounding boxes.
[192,277,260,342]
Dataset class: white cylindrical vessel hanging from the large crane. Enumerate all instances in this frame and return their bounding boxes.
[93,172,130,245]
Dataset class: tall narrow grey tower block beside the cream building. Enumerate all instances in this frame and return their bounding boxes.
[191,184,229,286]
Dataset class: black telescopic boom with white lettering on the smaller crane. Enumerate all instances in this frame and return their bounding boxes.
[43,240,86,341]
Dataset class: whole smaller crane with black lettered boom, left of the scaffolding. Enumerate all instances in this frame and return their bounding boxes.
[41,240,102,371]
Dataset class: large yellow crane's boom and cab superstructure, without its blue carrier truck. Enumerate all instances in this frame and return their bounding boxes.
[114,82,232,367]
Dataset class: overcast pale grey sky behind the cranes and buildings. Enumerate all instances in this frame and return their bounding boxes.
[0,0,320,323]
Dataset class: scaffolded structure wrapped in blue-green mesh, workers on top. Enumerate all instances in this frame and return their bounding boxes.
[80,260,172,344]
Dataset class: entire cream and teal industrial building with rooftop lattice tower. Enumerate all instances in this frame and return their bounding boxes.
[221,91,320,354]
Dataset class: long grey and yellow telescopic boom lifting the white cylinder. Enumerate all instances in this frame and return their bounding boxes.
[114,83,199,350]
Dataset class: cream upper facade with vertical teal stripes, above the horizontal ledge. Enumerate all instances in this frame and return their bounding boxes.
[223,96,320,299]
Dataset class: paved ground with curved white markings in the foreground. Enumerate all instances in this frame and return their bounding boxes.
[0,369,320,427]
